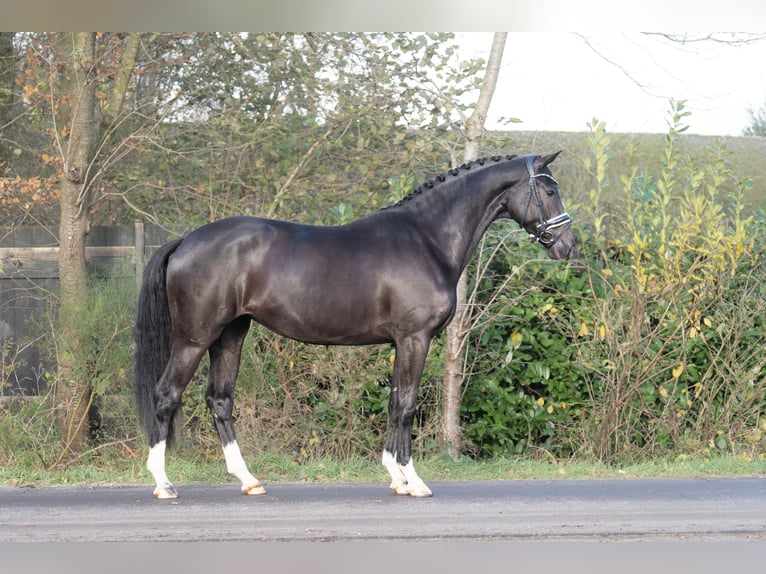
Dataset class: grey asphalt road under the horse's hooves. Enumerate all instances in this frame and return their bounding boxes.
[0,478,766,544]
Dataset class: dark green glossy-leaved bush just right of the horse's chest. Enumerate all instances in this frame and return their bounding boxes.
[461,238,587,457]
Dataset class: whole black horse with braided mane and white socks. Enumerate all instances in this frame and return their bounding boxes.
[135,152,575,498]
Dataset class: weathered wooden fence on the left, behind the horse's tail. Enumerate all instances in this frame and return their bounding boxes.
[0,222,168,396]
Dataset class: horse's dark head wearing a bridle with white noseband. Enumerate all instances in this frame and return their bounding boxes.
[507,151,575,259]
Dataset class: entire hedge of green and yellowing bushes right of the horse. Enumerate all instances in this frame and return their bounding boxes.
[463,103,766,462]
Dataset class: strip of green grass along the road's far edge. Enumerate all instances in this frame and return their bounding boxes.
[0,453,766,486]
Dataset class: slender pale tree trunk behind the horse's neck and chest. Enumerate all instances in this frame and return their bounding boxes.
[442,32,508,459]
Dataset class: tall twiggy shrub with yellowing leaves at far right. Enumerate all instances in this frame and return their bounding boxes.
[569,104,766,461]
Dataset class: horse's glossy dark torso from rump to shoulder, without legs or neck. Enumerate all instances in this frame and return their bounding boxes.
[168,218,454,344]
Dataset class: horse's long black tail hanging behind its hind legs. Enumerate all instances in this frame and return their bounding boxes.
[133,239,183,446]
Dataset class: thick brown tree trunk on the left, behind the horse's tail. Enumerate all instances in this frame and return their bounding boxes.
[55,32,98,451]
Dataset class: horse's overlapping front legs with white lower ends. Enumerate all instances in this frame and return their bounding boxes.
[382,335,431,497]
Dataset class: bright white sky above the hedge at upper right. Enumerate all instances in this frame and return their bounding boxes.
[456,32,766,135]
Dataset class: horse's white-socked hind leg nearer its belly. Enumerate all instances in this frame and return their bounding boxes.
[206,317,266,495]
